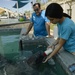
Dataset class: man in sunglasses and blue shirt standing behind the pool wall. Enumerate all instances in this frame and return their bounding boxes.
[25,3,51,37]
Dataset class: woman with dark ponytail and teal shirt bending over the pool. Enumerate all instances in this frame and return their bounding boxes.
[44,3,75,63]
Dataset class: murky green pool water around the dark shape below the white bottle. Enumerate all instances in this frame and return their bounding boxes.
[0,33,67,75]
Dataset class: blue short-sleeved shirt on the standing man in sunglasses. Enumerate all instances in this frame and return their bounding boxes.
[30,10,50,36]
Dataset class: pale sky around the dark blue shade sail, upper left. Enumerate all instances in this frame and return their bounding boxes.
[0,0,32,13]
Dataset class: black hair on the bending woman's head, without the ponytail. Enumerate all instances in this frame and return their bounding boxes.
[45,3,63,18]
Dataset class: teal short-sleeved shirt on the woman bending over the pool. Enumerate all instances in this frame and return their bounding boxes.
[57,18,75,52]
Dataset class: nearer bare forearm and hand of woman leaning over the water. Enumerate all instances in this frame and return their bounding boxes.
[44,38,66,63]
